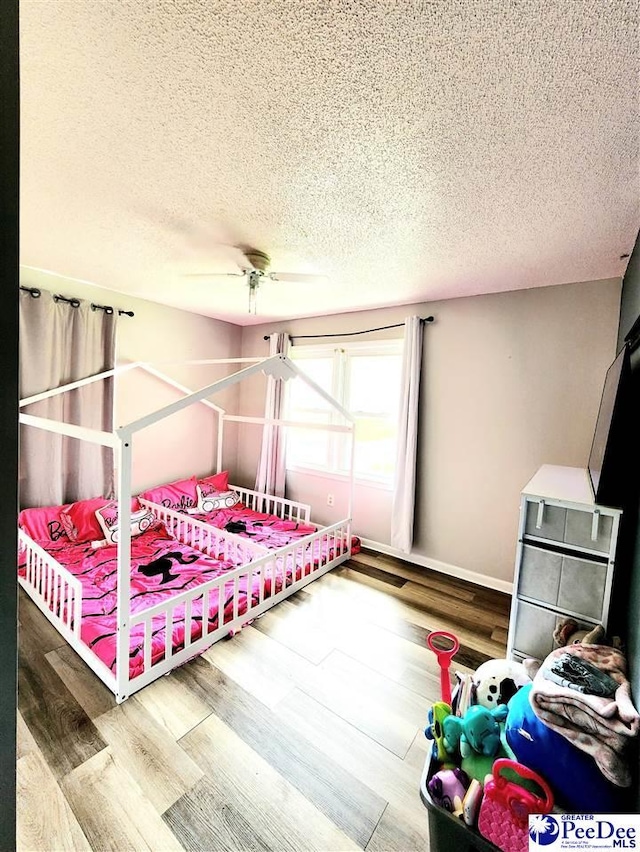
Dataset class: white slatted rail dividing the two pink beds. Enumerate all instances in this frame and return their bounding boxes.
[140,499,269,565]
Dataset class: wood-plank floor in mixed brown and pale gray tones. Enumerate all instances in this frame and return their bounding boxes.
[17,552,509,852]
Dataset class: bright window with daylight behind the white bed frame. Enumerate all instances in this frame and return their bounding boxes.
[287,340,402,484]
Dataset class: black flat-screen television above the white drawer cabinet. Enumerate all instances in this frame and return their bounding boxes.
[588,346,631,506]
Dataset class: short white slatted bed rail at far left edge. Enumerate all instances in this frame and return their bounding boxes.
[18,529,82,638]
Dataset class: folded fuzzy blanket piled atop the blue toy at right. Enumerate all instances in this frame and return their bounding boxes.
[530,645,640,787]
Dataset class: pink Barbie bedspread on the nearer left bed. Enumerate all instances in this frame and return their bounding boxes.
[19,526,290,677]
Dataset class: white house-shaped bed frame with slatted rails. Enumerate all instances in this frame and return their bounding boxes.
[19,354,354,703]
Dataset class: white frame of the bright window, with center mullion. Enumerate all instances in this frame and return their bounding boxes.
[286,338,404,491]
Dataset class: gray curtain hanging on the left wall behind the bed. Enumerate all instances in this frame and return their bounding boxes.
[20,290,117,508]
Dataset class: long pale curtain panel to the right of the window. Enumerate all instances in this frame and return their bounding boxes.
[391,317,422,553]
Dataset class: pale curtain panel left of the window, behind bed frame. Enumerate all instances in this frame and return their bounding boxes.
[256,331,289,497]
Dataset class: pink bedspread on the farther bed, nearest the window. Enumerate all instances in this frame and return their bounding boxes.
[191,503,360,559]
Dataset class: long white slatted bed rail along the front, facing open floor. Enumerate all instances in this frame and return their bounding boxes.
[125,513,351,701]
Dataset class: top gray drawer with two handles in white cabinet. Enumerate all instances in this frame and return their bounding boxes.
[524,500,613,553]
